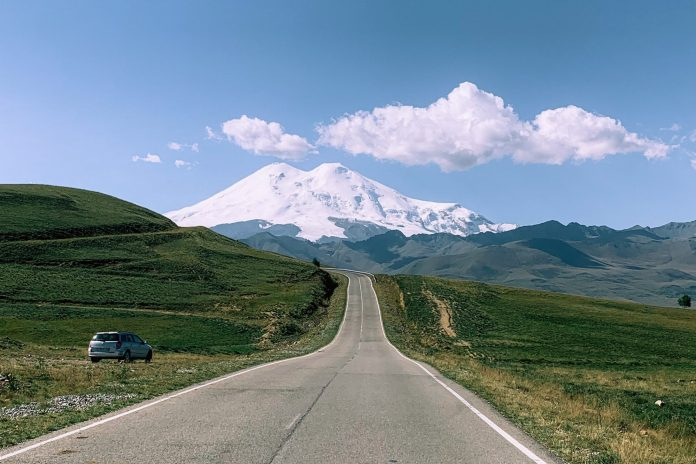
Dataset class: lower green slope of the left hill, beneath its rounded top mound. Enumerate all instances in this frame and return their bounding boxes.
[0,228,338,324]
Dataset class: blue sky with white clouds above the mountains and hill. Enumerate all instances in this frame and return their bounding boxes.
[0,0,696,228]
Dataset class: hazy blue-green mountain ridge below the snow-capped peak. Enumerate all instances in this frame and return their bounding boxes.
[243,221,696,306]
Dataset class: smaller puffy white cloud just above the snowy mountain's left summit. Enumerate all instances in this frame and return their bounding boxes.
[222,115,314,160]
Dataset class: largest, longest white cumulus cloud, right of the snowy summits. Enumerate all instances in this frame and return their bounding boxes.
[317,82,669,171]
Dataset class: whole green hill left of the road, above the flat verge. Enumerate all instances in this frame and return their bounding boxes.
[0,185,330,321]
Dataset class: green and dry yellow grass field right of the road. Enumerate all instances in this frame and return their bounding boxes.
[376,276,696,464]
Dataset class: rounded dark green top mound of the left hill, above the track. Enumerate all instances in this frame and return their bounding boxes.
[0,185,176,240]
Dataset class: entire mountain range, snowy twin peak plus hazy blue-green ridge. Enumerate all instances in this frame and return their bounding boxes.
[166,163,696,306]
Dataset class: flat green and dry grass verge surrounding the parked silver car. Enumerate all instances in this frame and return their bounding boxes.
[0,275,347,447]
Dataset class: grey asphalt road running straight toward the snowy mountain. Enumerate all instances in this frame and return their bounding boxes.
[0,273,556,464]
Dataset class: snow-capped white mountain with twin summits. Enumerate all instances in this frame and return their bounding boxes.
[166,163,516,241]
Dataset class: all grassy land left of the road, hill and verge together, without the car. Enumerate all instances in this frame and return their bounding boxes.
[0,186,344,446]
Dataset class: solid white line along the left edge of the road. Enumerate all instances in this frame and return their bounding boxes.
[0,277,350,461]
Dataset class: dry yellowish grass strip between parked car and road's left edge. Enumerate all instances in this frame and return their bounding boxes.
[0,275,347,447]
